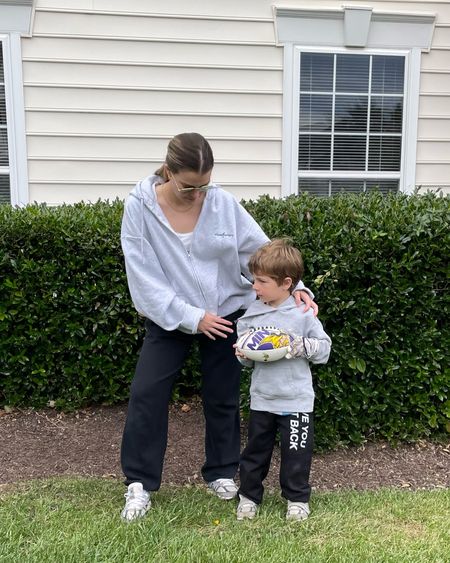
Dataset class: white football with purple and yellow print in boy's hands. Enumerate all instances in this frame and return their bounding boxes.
[236,326,291,362]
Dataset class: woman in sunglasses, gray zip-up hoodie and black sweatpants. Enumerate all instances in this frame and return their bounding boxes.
[121,133,316,521]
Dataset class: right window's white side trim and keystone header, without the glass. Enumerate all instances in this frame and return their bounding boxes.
[272,5,430,196]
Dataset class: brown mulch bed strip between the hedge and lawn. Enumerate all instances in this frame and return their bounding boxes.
[0,401,450,491]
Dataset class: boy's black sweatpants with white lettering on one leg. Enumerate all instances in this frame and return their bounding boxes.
[239,410,314,504]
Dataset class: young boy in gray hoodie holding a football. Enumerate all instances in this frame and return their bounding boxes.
[236,239,331,520]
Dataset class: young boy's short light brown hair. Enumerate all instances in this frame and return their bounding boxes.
[248,239,304,289]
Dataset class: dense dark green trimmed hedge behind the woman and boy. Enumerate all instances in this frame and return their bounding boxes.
[0,193,450,446]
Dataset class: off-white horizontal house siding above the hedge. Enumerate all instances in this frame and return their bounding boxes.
[22,0,450,203]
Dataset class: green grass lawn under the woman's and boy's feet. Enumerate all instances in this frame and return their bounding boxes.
[0,478,450,563]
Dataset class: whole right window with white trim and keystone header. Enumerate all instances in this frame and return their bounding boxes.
[273,2,436,196]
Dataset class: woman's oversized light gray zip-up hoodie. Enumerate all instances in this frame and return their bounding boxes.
[121,176,310,334]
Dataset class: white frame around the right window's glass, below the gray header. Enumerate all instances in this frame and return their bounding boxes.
[282,44,414,196]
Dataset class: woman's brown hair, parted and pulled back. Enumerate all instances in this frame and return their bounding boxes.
[155,133,214,182]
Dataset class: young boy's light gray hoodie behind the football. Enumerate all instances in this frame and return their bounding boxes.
[237,296,331,413]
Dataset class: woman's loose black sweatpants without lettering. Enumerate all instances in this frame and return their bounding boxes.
[121,311,243,491]
